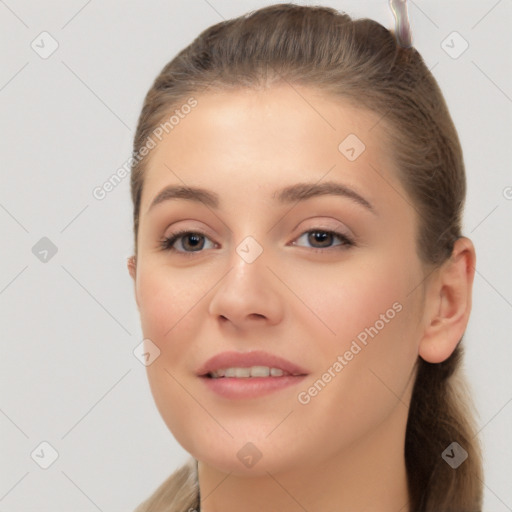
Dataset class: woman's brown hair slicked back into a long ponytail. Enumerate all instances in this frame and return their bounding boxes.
[131,4,483,512]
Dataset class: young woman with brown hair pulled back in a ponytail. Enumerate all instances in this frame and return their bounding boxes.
[128,4,482,512]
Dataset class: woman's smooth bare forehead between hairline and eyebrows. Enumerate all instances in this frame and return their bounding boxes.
[141,84,399,211]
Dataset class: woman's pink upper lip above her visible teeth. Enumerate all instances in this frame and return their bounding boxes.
[197,350,307,376]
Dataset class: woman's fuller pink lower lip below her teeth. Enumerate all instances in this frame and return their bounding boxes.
[201,375,306,399]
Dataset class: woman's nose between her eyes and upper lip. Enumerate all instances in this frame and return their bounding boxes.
[209,242,284,329]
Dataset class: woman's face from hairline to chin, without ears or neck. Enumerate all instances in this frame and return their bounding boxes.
[132,86,424,474]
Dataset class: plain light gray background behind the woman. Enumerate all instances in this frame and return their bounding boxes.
[0,0,512,512]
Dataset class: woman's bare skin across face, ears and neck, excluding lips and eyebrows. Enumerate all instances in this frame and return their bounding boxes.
[128,85,475,512]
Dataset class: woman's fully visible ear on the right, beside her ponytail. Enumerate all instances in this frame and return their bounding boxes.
[419,237,476,363]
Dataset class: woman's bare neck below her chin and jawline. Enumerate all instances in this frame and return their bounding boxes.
[198,402,409,512]
